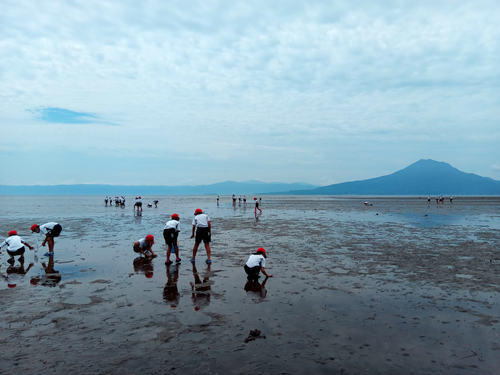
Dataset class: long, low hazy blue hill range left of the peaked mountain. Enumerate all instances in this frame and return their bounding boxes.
[0,180,318,196]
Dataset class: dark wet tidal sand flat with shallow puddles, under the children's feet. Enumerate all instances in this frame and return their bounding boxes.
[0,196,500,374]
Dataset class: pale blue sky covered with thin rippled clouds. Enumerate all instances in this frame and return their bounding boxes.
[0,0,500,185]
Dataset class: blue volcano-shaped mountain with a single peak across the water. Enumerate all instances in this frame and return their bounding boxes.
[282,160,500,195]
